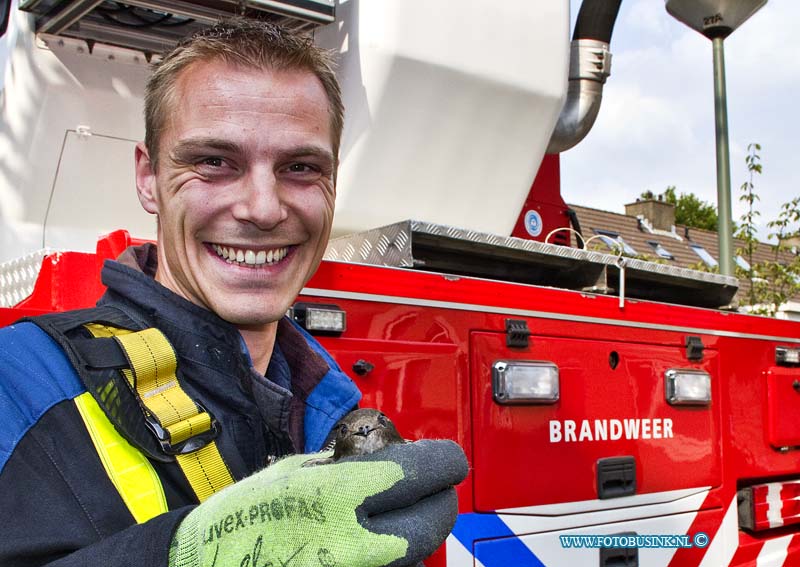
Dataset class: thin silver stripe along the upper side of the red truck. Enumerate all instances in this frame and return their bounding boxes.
[300,287,800,344]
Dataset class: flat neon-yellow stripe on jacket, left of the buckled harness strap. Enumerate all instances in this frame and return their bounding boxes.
[75,392,167,524]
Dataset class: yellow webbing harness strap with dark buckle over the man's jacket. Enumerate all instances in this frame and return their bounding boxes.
[86,323,233,502]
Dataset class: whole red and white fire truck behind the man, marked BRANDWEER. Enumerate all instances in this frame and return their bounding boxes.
[0,0,800,567]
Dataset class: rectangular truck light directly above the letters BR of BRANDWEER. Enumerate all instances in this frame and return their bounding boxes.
[492,360,559,404]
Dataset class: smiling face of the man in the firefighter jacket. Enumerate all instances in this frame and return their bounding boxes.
[136,61,335,329]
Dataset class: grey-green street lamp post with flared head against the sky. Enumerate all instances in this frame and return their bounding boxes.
[666,0,767,276]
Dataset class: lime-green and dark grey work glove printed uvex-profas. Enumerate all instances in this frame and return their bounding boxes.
[169,440,467,567]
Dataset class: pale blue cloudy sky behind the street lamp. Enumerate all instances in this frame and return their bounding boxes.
[561,0,800,240]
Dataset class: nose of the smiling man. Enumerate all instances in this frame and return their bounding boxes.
[233,169,288,229]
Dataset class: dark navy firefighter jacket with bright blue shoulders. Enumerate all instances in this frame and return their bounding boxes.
[0,245,360,567]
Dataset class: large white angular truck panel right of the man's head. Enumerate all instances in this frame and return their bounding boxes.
[315,0,569,239]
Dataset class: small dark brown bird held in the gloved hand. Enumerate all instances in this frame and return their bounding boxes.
[303,408,407,467]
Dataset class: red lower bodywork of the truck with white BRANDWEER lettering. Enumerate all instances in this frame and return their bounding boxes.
[0,224,800,567]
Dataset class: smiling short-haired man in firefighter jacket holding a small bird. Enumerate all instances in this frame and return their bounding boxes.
[0,20,467,567]
